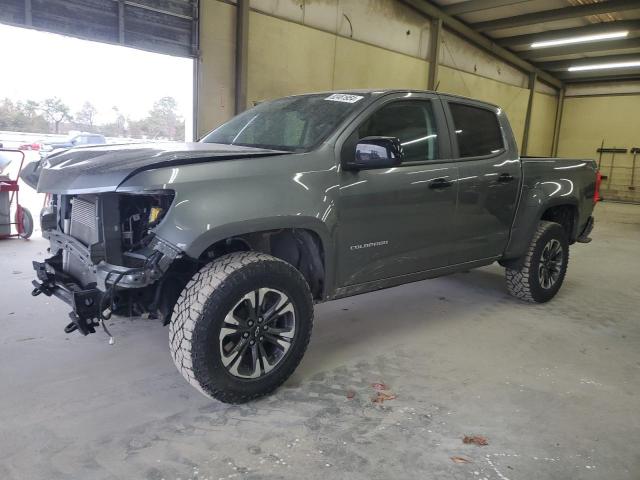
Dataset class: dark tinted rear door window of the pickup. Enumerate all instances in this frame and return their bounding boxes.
[449,102,504,157]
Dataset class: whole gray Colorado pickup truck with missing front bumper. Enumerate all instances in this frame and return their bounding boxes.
[26,90,599,402]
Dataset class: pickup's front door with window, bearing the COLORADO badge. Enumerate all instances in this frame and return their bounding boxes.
[337,92,457,286]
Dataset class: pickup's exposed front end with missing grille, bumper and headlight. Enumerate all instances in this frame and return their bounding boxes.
[32,190,182,335]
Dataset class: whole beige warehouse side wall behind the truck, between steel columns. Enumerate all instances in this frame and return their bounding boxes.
[199,0,555,154]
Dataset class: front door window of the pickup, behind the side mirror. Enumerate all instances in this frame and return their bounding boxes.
[357,100,438,162]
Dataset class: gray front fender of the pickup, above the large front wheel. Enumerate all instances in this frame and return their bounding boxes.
[118,148,338,276]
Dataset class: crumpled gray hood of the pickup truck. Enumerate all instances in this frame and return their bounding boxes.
[38,143,290,194]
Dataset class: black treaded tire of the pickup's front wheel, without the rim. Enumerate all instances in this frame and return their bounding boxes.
[169,252,313,403]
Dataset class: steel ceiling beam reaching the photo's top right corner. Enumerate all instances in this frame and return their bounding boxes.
[472,0,638,32]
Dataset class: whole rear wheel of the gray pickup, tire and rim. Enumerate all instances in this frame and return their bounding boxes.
[506,221,569,303]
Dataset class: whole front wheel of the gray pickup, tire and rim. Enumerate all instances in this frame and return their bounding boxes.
[169,252,313,403]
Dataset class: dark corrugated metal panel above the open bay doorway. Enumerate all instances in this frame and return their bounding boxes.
[0,0,198,57]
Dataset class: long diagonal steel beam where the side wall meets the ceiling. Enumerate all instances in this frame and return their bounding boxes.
[402,0,562,88]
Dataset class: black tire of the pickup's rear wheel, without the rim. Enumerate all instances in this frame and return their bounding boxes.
[506,221,569,303]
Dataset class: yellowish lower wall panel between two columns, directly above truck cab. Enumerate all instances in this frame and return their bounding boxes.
[247,12,428,105]
